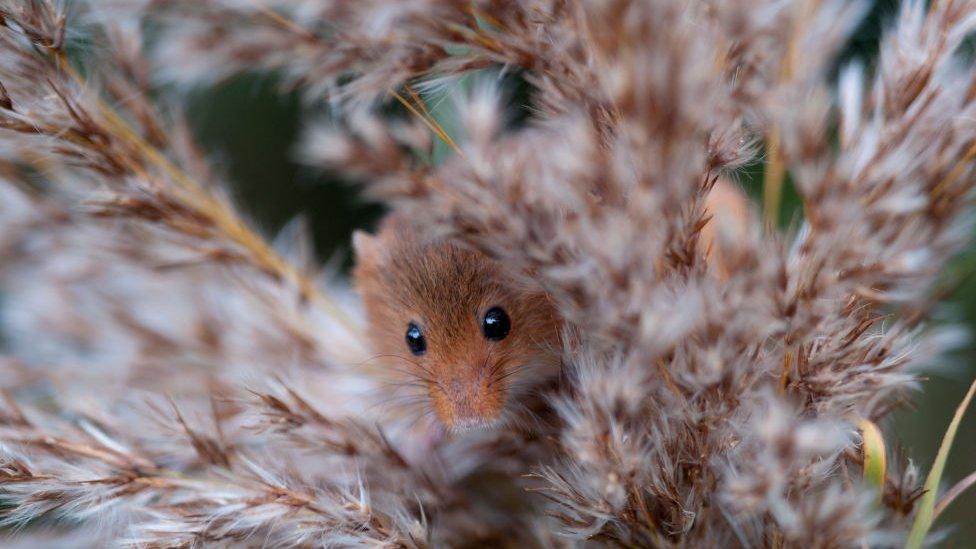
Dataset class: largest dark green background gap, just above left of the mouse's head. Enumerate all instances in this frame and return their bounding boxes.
[187,76,383,266]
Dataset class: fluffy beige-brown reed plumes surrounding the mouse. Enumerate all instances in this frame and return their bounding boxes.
[0,0,976,547]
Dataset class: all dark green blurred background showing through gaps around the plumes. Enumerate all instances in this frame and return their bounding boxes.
[188,0,976,547]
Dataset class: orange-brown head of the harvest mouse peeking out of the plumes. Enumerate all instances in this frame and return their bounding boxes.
[354,225,559,429]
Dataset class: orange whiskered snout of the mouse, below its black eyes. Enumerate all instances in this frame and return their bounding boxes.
[431,368,504,429]
